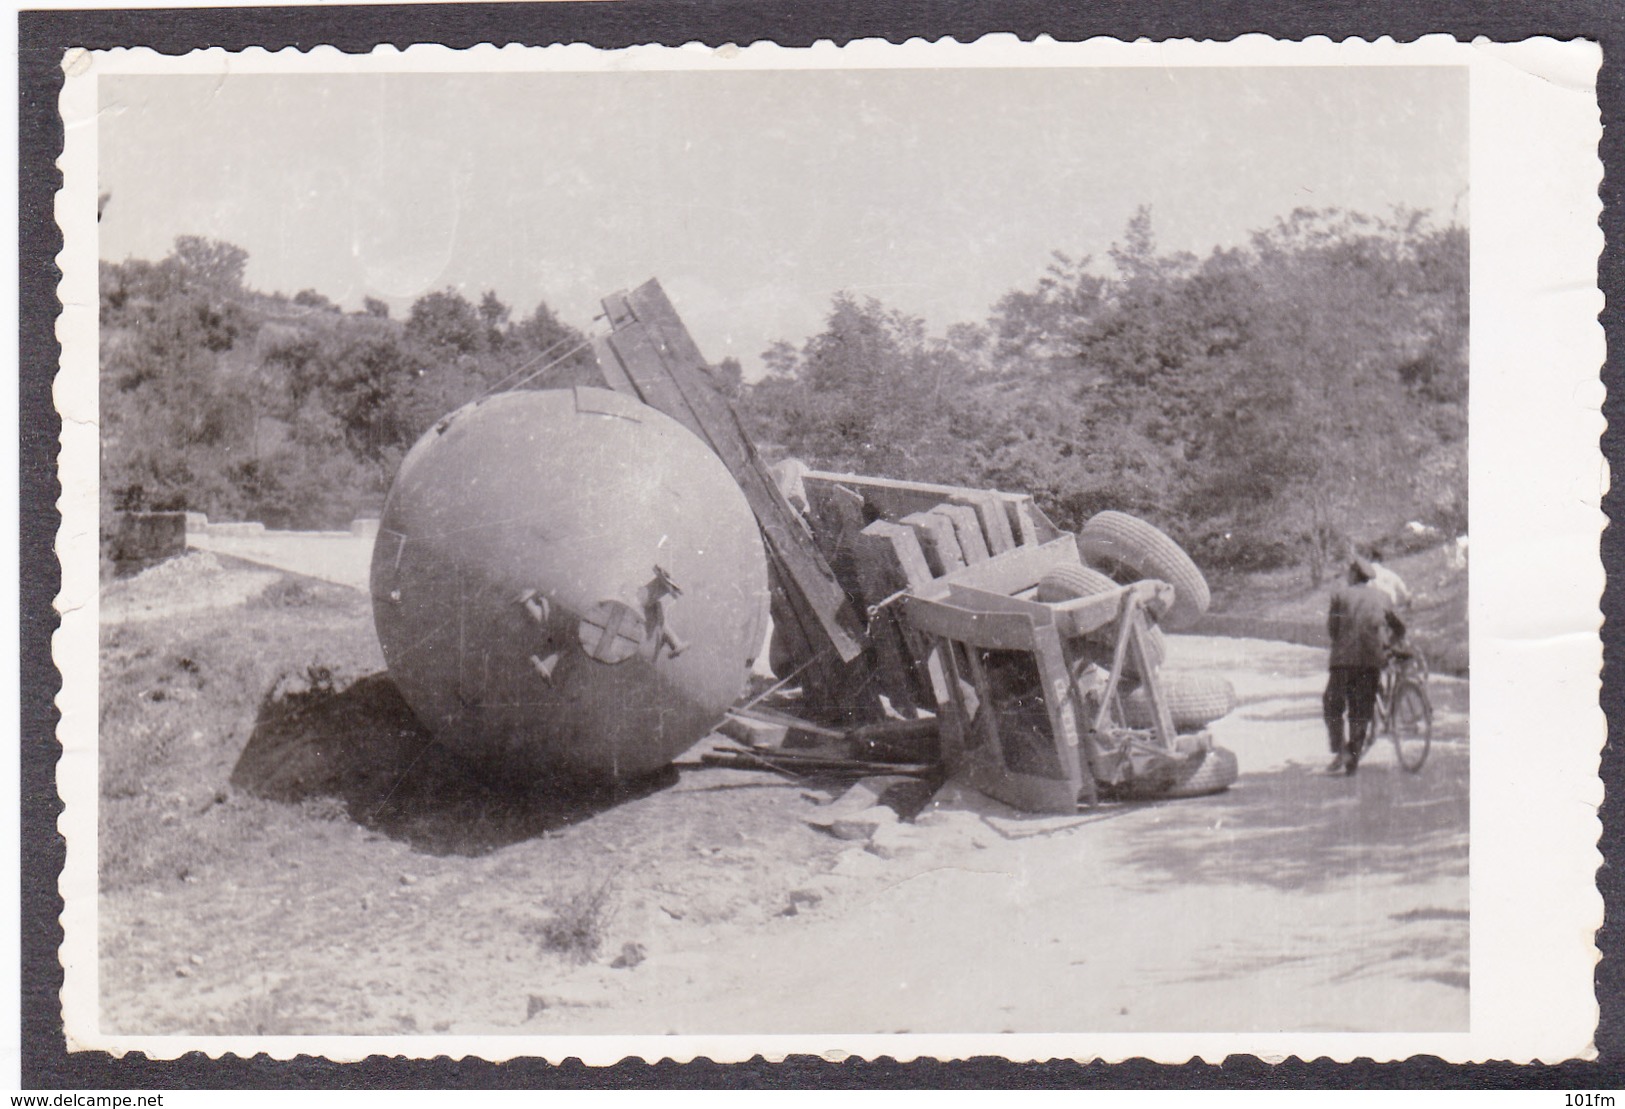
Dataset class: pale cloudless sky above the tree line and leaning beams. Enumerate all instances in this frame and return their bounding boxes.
[99,67,1467,374]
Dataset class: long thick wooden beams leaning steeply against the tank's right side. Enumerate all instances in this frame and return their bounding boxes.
[603,281,865,662]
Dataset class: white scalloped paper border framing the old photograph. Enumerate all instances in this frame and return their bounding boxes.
[52,36,1609,1063]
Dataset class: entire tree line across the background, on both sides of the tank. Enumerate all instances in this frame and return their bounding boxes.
[101,210,1467,581]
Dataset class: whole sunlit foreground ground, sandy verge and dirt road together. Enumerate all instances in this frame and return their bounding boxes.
[101,543,1469,1034]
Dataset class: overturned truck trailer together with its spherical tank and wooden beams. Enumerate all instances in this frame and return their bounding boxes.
[372,281,1237,811]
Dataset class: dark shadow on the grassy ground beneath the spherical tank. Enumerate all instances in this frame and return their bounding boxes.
[231,673,678,855]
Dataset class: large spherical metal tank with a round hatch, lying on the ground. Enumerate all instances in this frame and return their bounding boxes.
[372,387,767,781]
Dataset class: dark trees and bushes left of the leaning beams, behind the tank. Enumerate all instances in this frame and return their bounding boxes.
[101,237,587,528]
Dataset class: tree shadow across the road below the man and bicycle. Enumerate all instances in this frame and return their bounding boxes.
[1126,745,1467,891]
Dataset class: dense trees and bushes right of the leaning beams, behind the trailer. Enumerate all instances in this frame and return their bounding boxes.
[744,210,1467,581]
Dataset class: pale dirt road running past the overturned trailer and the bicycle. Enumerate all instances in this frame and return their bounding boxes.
[513,637,1467,1033]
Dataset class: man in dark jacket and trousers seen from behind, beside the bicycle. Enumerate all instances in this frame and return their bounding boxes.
[1321,558,1406,774]
